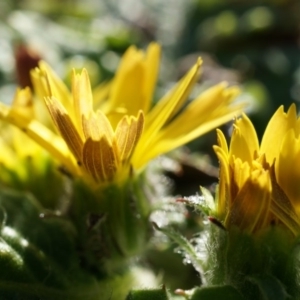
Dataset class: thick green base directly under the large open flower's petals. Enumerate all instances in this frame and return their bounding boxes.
[70,173,152,274]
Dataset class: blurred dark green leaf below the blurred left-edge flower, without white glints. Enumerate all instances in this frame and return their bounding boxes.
[0,190,76,267]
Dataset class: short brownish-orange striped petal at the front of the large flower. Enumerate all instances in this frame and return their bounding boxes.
[83,136,117,182]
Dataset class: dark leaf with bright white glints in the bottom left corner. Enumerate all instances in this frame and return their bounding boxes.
[0,227,102,300]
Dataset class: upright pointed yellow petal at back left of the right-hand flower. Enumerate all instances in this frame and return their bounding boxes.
[230,114,259,164]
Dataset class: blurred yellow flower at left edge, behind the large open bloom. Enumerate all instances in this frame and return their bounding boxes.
[0,88,64,208]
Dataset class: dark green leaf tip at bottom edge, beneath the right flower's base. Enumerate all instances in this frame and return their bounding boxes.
[190,285,244,300]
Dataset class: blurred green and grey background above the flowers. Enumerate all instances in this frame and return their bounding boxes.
[0,0,300,136]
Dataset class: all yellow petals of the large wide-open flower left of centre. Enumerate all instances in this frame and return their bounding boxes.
[0,43,244,183]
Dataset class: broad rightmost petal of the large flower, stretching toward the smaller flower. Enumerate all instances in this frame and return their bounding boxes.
[137,85,244,163]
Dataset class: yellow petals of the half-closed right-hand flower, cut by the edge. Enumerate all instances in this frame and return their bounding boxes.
[214,105,300,235]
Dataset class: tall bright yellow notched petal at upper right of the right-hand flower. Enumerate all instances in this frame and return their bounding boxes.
[260,104,297,165]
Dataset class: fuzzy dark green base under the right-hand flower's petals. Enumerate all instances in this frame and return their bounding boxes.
[204,224,300,300]
